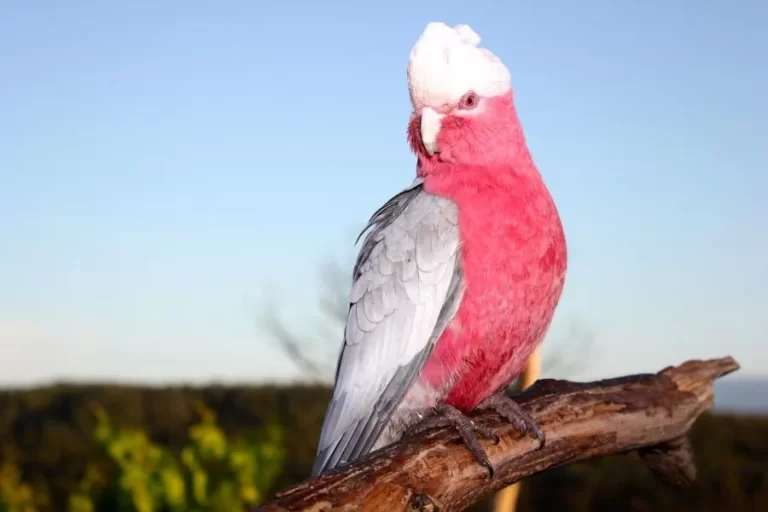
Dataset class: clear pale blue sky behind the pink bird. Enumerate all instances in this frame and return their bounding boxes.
[0,0,768,384]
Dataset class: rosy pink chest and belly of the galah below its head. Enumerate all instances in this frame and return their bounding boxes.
[420,173,566,410]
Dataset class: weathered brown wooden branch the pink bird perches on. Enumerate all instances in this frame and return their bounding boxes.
[256,357,739,512]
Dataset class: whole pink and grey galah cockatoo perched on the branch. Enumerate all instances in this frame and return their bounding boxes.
[313,23,566,475]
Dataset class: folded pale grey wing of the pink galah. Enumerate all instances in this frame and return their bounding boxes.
[312,180,463,475]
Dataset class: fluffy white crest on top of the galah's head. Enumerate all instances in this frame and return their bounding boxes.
[408,23,512,108]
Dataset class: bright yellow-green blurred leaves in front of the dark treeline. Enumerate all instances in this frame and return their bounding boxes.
[0,392,285,512]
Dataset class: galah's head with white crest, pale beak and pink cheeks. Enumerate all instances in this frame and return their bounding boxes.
[408,23,524,167]
